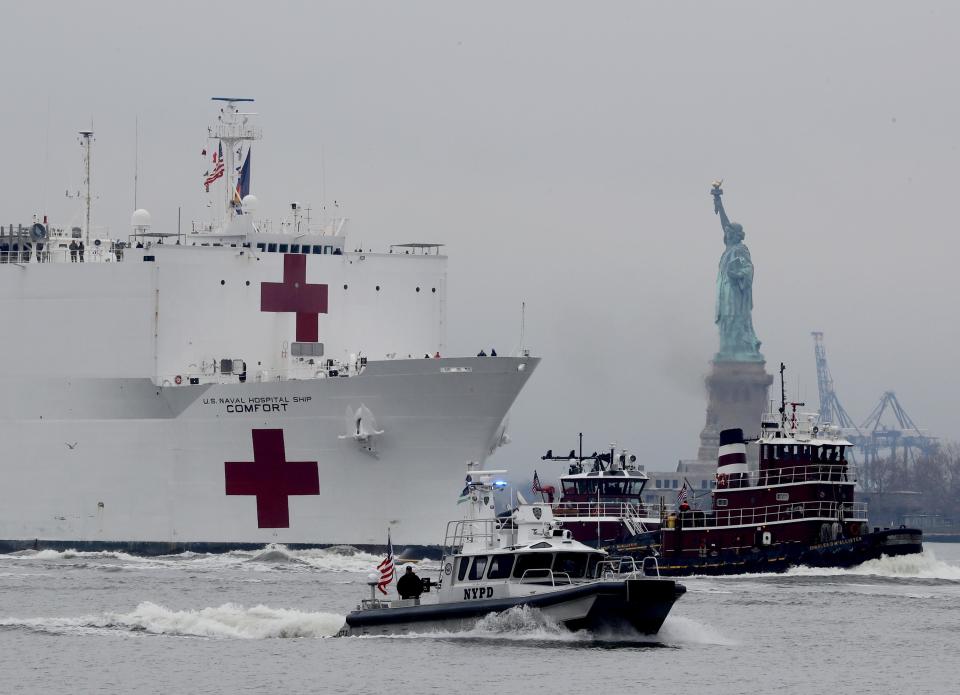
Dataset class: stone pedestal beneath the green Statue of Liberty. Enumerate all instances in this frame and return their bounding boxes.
[697,361,773,465]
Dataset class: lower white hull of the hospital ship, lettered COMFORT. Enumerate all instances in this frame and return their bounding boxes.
[0,358,537,552]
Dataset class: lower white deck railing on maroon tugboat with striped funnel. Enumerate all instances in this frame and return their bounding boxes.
[662,502,867,529]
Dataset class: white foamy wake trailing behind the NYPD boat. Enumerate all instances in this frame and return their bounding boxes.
[0,601,344,639]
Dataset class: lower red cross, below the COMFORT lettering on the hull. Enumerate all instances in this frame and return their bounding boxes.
[223,430,320,528]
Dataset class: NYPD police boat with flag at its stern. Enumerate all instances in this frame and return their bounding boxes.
[338,471,686,636]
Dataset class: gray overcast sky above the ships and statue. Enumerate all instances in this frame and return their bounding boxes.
[0,0,960,472]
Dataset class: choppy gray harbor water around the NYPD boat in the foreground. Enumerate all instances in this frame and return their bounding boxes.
[0,543,960,695]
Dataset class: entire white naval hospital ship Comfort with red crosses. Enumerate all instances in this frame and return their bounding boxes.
[0,99,538,552]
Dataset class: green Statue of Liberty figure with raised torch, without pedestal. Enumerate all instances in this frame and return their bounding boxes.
[711,181,764,362]
